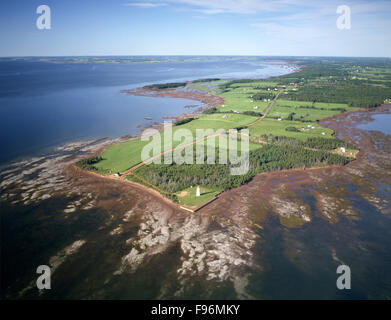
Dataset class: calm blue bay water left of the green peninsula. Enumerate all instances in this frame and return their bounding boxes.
[0,57,290,163]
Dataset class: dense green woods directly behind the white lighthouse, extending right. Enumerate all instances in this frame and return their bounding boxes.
[136,142,350,193]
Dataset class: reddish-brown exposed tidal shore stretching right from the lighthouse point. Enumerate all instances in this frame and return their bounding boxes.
[200,104,391,222]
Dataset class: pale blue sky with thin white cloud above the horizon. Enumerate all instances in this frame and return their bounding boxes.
[0,0,391,57]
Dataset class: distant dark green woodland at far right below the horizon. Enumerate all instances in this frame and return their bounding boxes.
[272,58,391,108]
